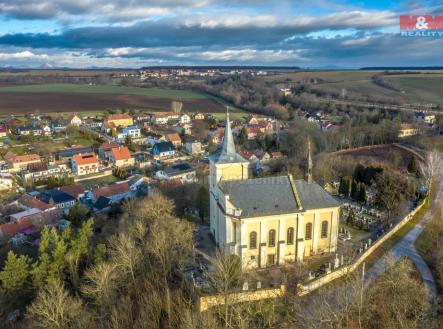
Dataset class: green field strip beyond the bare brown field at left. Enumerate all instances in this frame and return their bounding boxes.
[0,84,207,99]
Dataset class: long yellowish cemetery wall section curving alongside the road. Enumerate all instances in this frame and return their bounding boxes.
[297,200,426,296]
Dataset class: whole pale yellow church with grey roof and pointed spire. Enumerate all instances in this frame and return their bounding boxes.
[209,113,340,269]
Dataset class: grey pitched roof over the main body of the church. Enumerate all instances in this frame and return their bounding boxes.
[219,176,340,218]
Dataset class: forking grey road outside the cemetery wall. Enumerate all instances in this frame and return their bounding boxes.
[366,174,443,322]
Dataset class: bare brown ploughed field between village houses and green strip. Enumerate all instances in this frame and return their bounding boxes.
[0,92,224,115]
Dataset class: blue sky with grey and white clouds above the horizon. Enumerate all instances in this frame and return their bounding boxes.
[0,0,443,68]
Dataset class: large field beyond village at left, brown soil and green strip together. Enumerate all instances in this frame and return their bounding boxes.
[0,84,231,115]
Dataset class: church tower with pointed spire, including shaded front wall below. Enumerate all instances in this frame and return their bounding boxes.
[209,110,249,243]
